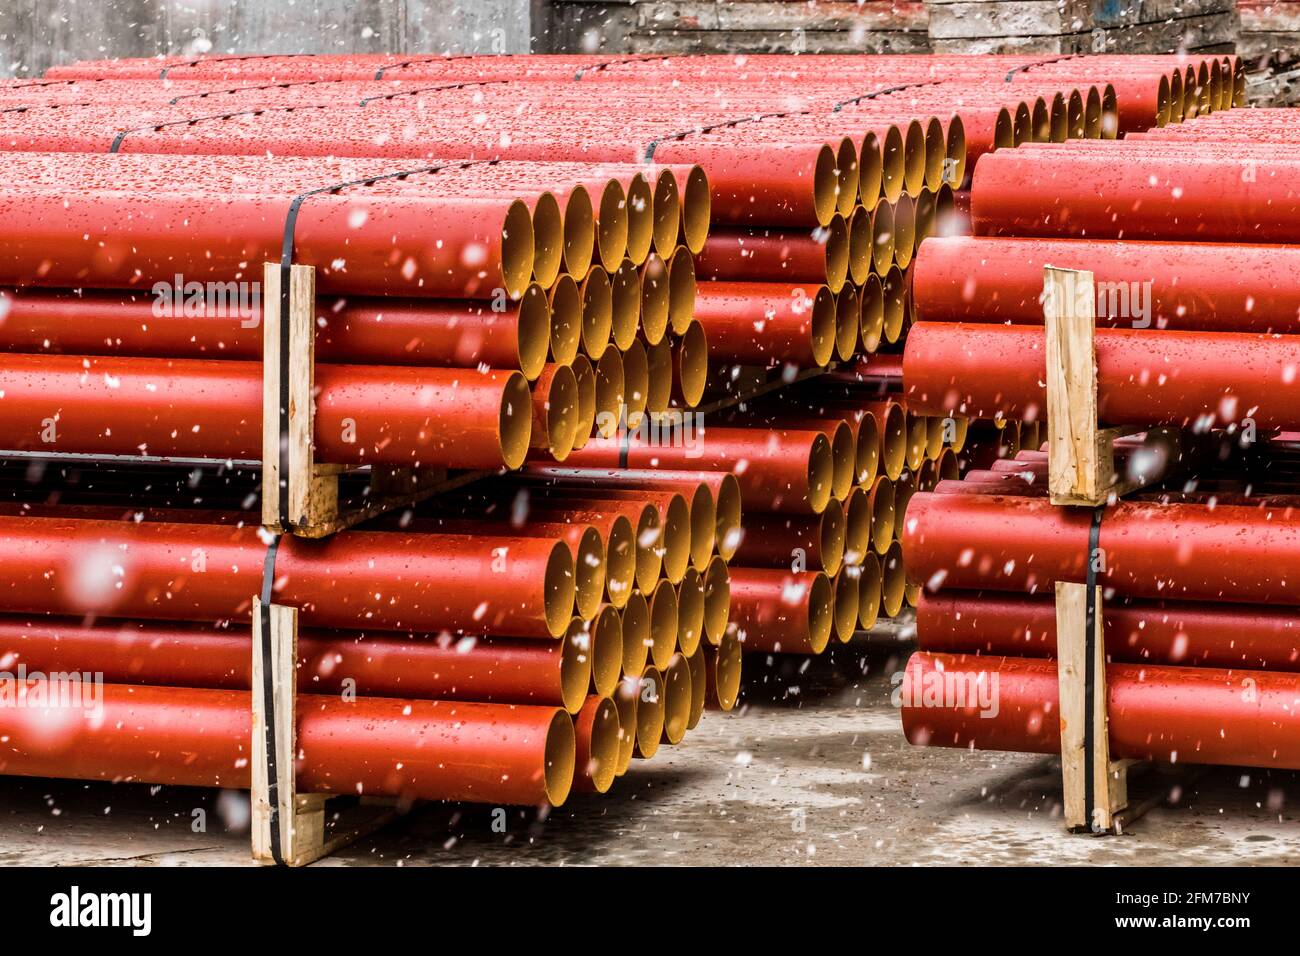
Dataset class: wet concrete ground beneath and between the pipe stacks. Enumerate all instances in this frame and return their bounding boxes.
[0,634,1300,866]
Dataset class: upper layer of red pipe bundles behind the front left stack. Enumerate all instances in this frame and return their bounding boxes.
[0,50,1216,367]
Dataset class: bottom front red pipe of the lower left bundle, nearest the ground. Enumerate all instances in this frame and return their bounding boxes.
[0,684,573,804]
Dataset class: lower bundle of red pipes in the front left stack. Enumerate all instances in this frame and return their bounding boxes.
[0,466,741,805]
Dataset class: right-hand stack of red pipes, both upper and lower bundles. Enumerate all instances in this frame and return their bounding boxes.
[904,102,1300,769]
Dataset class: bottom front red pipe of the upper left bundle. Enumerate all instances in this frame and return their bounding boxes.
[0,354,532,468]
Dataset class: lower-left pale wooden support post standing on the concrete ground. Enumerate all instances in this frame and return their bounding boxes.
[250,598,397,866]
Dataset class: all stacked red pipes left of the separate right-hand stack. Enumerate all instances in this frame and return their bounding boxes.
[0,57,1239,803]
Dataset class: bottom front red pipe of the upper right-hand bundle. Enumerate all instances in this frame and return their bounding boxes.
[904,323,1300,428]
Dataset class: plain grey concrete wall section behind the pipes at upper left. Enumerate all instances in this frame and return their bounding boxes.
[0,0,546,75]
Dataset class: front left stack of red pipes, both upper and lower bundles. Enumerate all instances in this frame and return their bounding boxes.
[0,67,740,804]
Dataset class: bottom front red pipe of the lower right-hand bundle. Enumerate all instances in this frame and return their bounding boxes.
[902,652,1300,770]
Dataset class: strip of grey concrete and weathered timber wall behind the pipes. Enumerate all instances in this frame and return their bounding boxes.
[0,0,1300,83]
